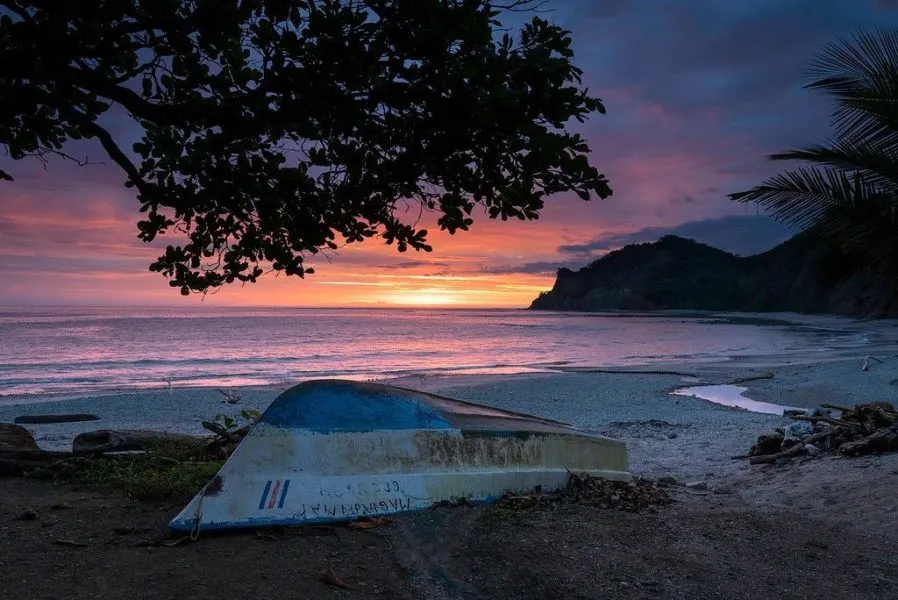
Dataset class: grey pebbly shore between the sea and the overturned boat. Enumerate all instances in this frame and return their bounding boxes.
[0,348,898,478]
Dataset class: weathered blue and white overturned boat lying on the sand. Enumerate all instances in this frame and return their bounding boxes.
[170,380,630,532]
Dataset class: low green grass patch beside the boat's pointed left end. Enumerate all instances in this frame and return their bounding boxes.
[29,442,224,501]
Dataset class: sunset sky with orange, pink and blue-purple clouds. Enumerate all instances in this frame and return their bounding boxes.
[0,0,898,308]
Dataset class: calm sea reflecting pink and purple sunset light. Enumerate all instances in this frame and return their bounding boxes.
[0,308,867,396]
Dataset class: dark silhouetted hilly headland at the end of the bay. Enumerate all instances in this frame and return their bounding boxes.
[530,232,898,318]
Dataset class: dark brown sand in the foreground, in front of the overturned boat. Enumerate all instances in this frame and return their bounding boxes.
[0,474,898,600]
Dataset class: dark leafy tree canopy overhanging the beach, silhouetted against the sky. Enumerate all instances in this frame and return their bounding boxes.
[0,0,611,295]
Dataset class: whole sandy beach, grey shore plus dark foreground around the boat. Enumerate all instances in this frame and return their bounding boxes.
[0,347,898,598]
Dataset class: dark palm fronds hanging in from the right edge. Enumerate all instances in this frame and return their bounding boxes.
[730,29,898,280]
